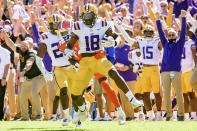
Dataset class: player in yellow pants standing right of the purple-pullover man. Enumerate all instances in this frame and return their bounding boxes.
[181,26,197,121]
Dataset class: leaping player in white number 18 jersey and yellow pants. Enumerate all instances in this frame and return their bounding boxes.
[65,4,143,124]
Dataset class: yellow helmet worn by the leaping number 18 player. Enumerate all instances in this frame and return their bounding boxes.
[81,4,98,28]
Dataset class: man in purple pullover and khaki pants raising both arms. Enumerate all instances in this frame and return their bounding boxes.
[156,10,186,121]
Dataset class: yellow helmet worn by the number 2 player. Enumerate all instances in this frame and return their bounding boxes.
[48,14,63,33]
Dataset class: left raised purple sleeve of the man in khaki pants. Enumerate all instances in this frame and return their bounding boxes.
[156,20,168,46]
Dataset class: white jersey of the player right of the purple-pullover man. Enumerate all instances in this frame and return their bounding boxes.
[181,40,195,73]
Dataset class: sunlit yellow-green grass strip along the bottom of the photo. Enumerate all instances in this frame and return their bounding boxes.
[0,121,197,131]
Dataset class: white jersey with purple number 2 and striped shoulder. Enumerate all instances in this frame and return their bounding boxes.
[40,32,70,67]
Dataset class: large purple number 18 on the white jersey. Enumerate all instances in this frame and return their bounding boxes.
[85,35,100,51]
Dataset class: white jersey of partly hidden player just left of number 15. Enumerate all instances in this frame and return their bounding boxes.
[129,50,143,76]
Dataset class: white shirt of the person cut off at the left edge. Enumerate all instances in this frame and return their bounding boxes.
[0,46,10,79]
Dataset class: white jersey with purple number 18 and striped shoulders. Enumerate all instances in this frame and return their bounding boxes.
[72,19,114,53]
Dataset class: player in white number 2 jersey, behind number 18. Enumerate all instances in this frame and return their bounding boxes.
[37,14,76,125]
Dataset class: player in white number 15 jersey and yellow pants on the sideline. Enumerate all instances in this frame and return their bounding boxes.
[115,20,162,121]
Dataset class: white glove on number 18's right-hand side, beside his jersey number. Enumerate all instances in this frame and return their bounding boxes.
[100,36,115,47]
